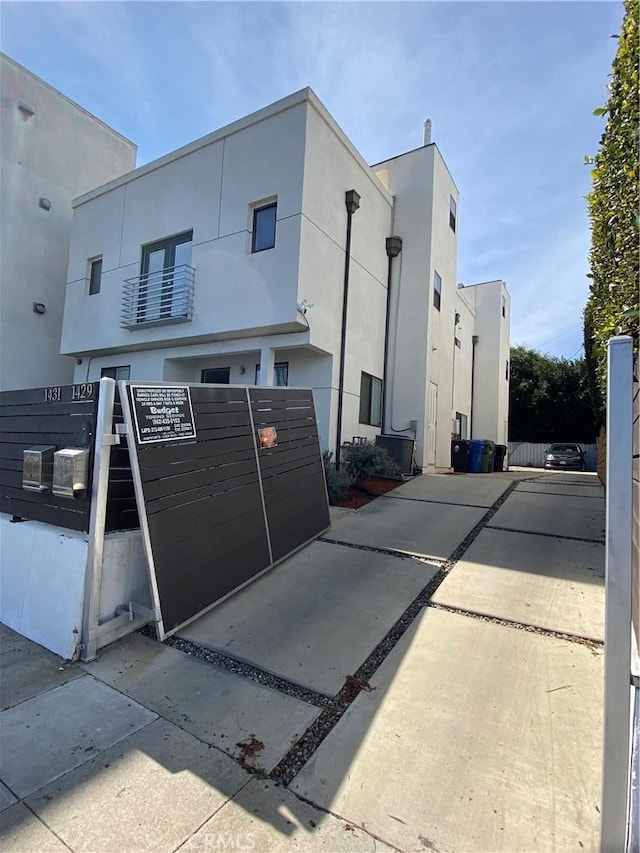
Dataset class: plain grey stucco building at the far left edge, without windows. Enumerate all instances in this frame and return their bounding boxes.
[0,54,136,390]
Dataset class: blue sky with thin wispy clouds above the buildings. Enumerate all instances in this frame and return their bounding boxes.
[0,0,624,358]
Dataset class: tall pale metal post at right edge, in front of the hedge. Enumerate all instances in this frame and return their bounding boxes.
[600,337,633,853]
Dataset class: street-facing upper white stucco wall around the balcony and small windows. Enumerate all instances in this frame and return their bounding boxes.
[62,98,306,357]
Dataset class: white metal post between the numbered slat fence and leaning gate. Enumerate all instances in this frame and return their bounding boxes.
[81,378,119,661]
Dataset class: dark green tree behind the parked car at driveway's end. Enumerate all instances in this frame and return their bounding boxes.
[509,347,598,443]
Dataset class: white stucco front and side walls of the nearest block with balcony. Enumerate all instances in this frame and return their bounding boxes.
[63,90,392,456]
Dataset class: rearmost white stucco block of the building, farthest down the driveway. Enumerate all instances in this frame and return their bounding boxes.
[464,281,511,445]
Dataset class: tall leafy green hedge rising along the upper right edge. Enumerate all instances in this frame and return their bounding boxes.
[584,0,640,409]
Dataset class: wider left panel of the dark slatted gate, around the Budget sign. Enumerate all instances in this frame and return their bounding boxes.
[127,383,271,639]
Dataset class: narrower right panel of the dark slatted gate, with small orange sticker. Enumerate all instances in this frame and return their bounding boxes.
[249,387,330,562]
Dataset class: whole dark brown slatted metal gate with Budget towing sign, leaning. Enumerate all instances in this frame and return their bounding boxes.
[120,383,329,639]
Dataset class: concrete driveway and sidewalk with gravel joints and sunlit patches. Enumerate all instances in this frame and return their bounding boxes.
[0,470,604,853]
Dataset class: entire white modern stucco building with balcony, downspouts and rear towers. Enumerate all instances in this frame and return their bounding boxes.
[61,89,509,470]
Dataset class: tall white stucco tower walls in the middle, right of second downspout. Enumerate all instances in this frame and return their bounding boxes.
[374,144,459,468]
